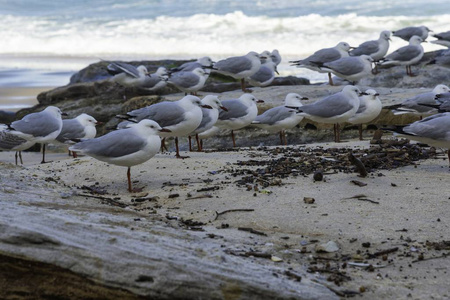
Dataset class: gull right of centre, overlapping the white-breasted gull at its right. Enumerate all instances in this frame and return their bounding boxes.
[288,85,364,143]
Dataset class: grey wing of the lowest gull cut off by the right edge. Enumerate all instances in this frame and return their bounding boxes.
[403,113,450,140]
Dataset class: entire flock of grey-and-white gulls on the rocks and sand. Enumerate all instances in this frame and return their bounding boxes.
[0,26,450,192]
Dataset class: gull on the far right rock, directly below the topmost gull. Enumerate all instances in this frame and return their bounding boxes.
[381,35,424,76]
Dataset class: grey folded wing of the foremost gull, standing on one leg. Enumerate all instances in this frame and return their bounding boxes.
[70,129,146,157]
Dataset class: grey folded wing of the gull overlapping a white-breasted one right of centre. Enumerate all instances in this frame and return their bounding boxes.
[299,93,353,118]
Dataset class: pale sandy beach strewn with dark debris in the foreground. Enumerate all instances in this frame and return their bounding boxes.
[0,133,450,299]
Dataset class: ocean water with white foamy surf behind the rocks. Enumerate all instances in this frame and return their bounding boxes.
[0,0,450,109]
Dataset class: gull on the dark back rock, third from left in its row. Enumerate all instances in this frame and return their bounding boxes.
[167,67,209,94]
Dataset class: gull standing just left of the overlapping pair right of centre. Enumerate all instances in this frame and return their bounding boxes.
[252,93,308,145]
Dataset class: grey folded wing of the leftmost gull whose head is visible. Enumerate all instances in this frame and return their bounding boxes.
[11,112,60,137]
